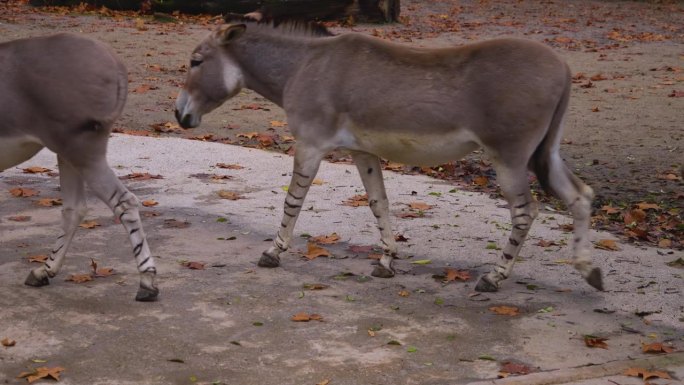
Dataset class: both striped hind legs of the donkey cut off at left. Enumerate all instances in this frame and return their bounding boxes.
[26,157,159,301]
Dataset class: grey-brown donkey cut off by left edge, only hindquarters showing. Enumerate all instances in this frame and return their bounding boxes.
[0,34,159,301]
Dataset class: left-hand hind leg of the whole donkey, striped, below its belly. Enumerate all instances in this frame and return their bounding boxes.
[475,164,538,292]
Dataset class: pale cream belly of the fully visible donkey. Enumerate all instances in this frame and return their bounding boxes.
[354,130,480,166]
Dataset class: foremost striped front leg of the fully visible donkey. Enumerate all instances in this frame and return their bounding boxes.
[258,143,326,267]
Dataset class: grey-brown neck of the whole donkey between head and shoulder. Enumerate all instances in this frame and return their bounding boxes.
[232,35,313,107]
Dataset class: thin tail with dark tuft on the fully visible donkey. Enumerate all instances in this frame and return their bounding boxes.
[528,65,584,198]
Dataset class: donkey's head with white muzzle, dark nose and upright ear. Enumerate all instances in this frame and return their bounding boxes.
[176,24,246,128]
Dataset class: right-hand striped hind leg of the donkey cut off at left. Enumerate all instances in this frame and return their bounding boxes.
[82,159,159,302]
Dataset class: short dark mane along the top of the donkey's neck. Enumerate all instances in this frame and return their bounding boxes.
[224,14,334,37]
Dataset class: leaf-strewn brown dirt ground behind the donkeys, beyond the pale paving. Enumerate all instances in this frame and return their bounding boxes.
[0,0,684,248]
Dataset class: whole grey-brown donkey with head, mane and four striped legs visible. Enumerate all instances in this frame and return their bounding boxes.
[176,23,603,291]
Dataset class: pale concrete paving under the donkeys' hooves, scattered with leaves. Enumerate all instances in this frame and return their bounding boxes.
[0,135,684,385]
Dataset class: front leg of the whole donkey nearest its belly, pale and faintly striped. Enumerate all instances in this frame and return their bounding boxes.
[352,152,397,278]
